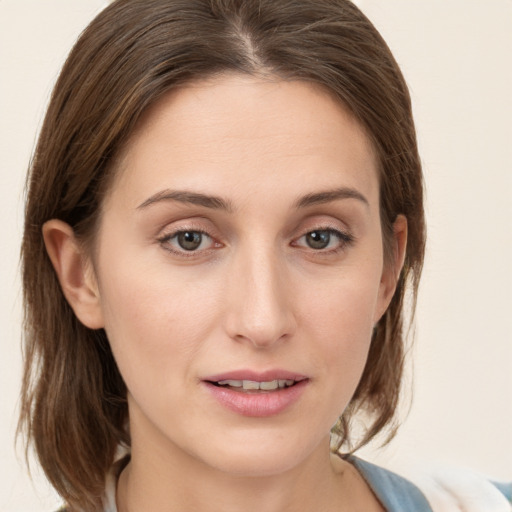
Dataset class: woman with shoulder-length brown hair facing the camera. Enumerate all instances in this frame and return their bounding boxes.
[18,0,510,511]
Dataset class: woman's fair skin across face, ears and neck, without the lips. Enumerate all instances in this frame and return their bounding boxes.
[44,75,406,512]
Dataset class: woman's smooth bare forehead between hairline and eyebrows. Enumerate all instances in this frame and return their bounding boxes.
[112,75,378,208]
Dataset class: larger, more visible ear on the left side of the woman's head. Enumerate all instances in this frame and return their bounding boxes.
[43,219,104,329]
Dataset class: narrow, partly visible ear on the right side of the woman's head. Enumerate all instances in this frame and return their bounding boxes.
[375,215,407,323]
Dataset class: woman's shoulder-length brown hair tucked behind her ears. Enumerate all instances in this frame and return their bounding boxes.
[20,0,425,510]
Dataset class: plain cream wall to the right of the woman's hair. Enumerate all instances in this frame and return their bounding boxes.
[359,0,512,480]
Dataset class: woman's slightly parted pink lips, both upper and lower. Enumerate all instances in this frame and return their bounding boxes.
[202,370,309,418]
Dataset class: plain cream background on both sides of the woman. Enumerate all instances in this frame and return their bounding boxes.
[0,0,512,512]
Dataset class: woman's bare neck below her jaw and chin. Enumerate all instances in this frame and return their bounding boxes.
[117,434,352,512]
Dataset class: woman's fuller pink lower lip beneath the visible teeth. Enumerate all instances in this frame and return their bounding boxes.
[203,379,309,418]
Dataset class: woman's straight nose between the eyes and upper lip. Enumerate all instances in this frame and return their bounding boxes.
[226,243,296,348]
